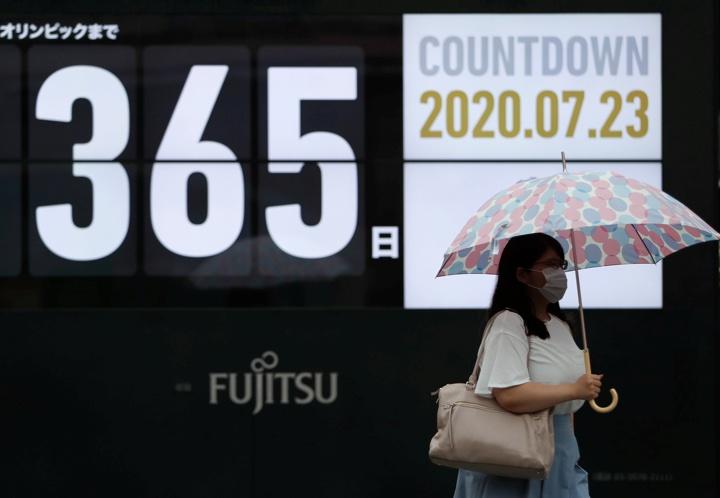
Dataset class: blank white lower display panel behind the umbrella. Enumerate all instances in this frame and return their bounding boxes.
[403,163,660,308]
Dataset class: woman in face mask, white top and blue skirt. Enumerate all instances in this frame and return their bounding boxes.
[454,233,602,498]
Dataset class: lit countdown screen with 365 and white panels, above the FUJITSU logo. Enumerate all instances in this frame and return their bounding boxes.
[0,14,676,308]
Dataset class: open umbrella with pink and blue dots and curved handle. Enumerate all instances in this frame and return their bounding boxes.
[437,154,720,413]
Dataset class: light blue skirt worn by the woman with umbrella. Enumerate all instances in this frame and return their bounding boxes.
[453,413,590,498]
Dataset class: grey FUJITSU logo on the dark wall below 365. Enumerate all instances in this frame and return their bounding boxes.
[209,351,338,415]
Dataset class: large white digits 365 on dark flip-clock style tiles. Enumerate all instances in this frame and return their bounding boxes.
[0,45,366,280]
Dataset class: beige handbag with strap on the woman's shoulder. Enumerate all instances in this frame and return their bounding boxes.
[429,313,555,479]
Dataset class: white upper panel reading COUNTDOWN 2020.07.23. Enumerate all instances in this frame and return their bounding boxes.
[403,14,662,161]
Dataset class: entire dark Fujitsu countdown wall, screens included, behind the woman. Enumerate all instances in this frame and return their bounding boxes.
[0,5,720,498]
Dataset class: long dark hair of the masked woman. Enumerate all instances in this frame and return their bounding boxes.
[488,233,569,339]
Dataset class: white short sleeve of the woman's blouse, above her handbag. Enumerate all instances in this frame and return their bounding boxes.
[475,311,530,398]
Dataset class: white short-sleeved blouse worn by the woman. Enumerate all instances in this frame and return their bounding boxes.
[475,310,585,414]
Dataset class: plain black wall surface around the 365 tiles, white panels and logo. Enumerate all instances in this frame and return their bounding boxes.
[0,1,720,498]
